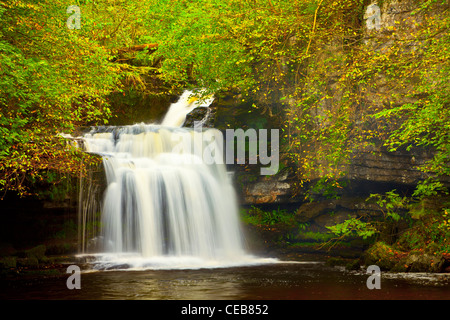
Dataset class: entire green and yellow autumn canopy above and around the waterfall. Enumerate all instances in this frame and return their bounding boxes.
[0,0,450,229]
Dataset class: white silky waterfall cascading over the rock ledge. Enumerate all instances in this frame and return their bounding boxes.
[84,92,278,269]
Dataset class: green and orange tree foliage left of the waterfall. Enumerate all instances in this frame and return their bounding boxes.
[0,0,119,195]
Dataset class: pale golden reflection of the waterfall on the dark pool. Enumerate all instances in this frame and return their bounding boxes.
[83,270,253,300]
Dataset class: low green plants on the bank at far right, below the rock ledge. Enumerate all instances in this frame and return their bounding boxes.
[327,183,450,254]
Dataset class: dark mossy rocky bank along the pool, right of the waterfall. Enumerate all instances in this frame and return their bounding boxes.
[244,209,450,274]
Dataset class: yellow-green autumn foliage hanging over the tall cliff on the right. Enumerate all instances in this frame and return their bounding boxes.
[282,1,450,192]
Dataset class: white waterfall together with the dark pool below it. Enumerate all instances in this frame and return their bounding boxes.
[0,93,450,302]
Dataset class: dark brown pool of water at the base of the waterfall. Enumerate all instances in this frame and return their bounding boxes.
[0,263,450,300]
